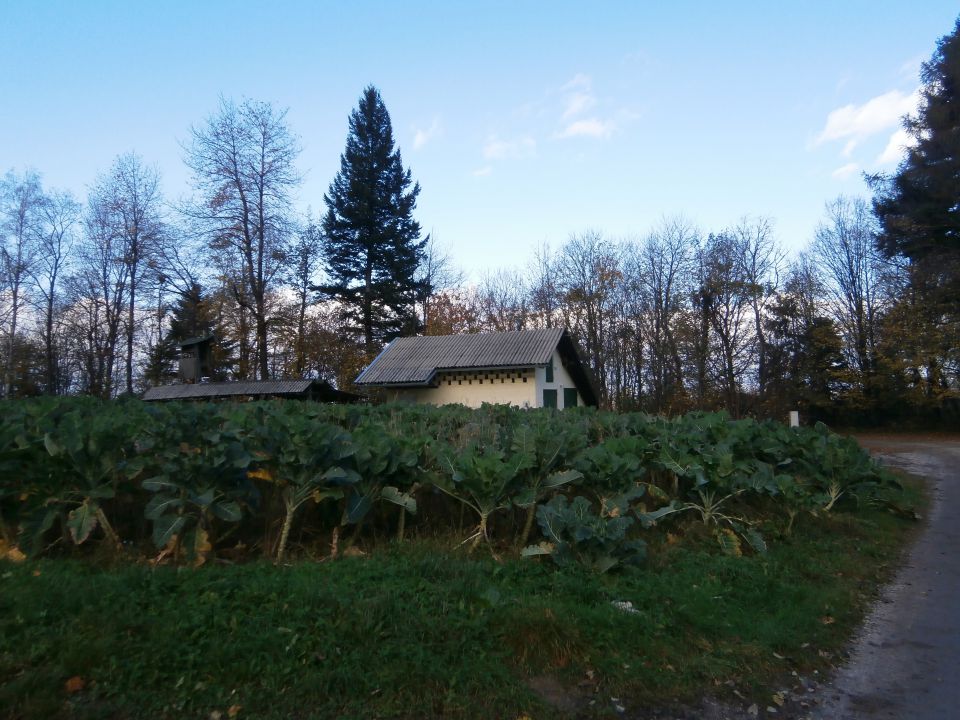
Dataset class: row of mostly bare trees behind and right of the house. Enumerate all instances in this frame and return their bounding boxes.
[427,197,958,423]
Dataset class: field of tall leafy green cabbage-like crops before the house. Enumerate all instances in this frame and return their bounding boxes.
[0,398,894,572]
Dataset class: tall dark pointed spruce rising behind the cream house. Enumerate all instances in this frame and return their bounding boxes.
[318,85,429,355]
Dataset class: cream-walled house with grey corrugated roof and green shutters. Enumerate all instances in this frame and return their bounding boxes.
[354,328,599,408]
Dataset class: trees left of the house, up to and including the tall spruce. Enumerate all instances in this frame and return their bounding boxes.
[0,87,430,397]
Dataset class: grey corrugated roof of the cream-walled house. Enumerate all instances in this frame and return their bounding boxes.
[354,328,564,385]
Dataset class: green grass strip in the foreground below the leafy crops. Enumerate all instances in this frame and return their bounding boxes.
[0,476,921,719]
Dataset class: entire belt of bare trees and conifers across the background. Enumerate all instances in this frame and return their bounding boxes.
[0,24,960,427]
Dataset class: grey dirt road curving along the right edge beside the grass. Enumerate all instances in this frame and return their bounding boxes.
[814,437,960,720]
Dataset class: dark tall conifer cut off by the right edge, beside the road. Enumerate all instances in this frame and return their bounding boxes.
[868,19,960,422]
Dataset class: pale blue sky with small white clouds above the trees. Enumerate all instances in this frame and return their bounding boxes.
[0,0,960,280]
